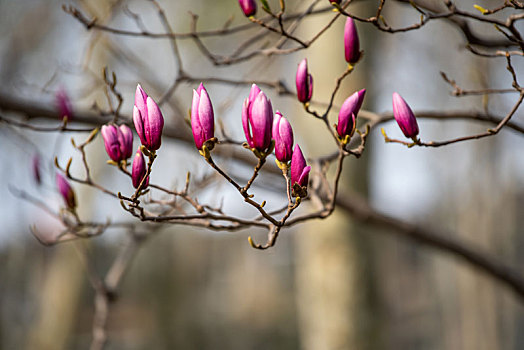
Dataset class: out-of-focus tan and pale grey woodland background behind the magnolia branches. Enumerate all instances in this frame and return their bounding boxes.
[0,0,524,350]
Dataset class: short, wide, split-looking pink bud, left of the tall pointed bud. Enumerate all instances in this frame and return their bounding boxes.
[102,124,133,163]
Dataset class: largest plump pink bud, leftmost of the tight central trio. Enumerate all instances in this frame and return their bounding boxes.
[242,84,273,152]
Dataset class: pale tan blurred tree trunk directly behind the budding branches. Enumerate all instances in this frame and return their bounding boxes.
[295,2,375,350]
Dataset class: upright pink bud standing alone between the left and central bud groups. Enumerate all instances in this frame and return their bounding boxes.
[191,83,215,150]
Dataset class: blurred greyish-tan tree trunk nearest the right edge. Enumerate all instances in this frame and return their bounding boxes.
[448,50,516,350]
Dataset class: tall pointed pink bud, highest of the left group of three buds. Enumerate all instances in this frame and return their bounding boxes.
[133,84,164,151]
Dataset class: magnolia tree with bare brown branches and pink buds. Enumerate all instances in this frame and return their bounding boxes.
[2,0,524,349]
